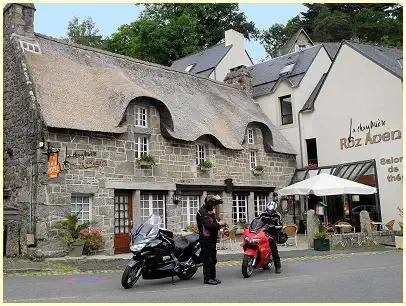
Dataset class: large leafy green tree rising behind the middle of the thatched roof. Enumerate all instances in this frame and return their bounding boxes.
[103,3,258,65]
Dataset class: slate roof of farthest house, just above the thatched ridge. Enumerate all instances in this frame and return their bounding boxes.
[171,43,232,77]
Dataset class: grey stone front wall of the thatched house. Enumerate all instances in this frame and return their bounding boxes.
[29,99,295,253]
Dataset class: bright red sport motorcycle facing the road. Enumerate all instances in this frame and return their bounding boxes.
[241,218,282,278]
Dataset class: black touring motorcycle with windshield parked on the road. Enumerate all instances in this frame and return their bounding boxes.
[121,216,203,289]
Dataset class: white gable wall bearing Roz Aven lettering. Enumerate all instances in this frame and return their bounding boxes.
[303,45,403,221]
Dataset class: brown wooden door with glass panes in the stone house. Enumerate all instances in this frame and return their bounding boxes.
[114,191,133,254]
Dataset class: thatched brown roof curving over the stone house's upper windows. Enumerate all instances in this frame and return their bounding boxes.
[24,34,296,154]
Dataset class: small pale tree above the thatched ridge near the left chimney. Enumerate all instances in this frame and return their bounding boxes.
[68,17,103,47]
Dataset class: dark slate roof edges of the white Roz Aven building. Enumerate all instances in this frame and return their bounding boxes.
[300,41,403,112]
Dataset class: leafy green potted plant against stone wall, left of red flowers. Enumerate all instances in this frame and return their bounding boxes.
[55,213,90,257]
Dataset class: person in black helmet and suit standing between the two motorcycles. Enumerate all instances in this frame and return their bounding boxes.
[196,195,225,285]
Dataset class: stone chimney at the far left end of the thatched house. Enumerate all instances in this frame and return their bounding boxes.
[3,3,35,37]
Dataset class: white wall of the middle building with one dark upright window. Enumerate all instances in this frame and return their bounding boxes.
[255,48,331,168]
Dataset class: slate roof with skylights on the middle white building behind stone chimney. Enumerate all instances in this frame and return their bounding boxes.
[248,45,323,98]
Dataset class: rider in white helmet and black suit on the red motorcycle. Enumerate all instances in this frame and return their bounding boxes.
[260,202,282,274]
